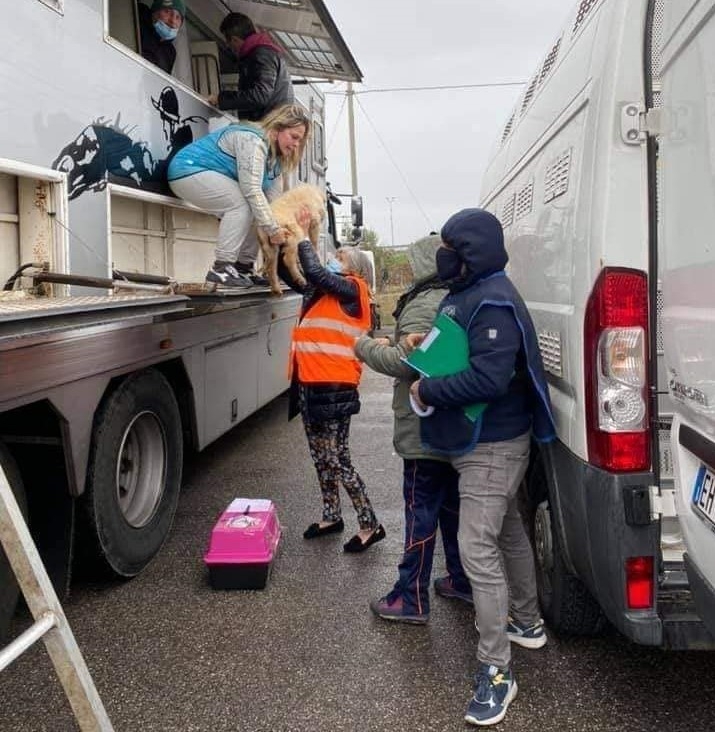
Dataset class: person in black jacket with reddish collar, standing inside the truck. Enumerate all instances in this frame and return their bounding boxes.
[207,13,294,120]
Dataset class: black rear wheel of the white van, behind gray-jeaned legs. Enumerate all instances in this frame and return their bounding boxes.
[532,501,605,635]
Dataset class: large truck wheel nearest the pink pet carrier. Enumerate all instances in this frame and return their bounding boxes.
[82,369,183,577]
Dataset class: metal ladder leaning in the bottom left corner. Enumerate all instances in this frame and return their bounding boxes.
[0,466,113,732]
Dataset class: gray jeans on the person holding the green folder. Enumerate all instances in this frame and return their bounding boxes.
[452,432,539,669]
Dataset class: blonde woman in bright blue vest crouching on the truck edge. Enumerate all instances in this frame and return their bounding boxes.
[168,104,310,287]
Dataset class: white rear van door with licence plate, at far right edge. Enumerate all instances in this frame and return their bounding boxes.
[661,0,715,634]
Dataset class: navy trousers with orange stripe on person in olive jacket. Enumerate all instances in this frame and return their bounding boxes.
[390,460,470,614]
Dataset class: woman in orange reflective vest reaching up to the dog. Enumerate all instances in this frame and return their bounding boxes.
[279,240,385,553]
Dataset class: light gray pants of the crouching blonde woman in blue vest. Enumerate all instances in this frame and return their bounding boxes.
[169,170,258,264]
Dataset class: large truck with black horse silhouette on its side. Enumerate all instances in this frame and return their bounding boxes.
[0,0,361,633]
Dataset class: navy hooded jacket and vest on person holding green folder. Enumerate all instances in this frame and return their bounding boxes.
[419,208,554,455]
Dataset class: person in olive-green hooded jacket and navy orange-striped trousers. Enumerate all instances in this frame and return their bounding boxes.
[355,236,472,624]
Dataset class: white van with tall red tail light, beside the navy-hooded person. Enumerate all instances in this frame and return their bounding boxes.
[481,0,715,648]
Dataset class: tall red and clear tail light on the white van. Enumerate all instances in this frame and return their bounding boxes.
[584,267,650,472]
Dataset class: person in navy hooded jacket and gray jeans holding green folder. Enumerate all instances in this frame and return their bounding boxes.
[407,208,554,725]
